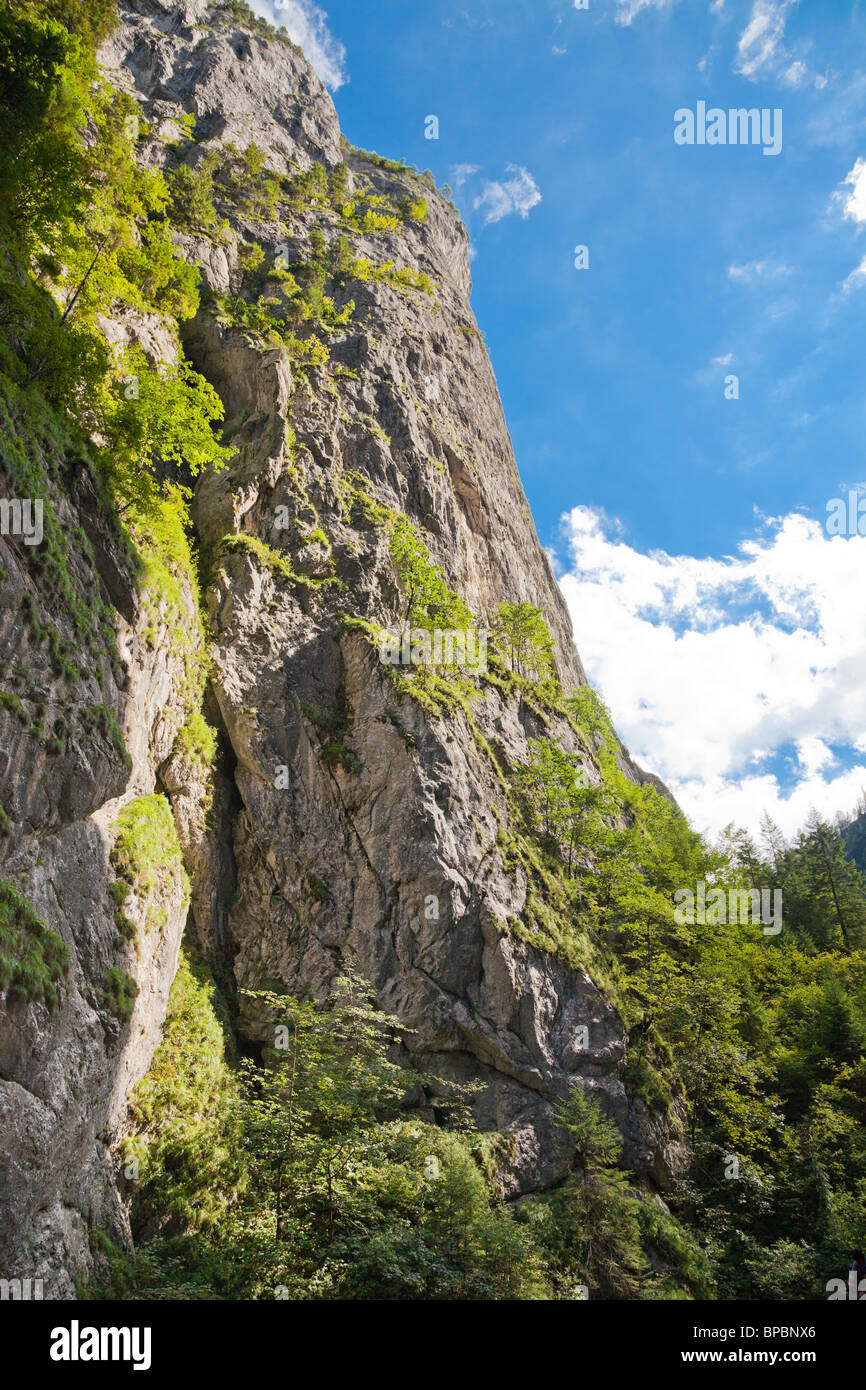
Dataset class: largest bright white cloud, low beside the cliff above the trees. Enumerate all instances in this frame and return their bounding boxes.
[560,507,866,834]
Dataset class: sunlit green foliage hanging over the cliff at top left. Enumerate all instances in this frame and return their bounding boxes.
[0,3,233,683]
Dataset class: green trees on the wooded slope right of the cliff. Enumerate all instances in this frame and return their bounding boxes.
[500,687,866,1298]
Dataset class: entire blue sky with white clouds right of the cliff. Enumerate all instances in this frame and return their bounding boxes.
[254,0,866,830]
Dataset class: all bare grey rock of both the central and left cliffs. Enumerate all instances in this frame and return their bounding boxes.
[0,0,680,1295]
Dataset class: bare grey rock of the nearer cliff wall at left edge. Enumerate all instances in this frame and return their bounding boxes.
[0,459,197,1297]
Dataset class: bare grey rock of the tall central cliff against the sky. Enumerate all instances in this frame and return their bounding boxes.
[104,4,676,1193]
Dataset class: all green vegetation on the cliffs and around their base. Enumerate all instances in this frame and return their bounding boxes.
[6,0,866,1300]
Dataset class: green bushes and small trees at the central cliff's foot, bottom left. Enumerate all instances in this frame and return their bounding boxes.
[89,962,546,1300]
